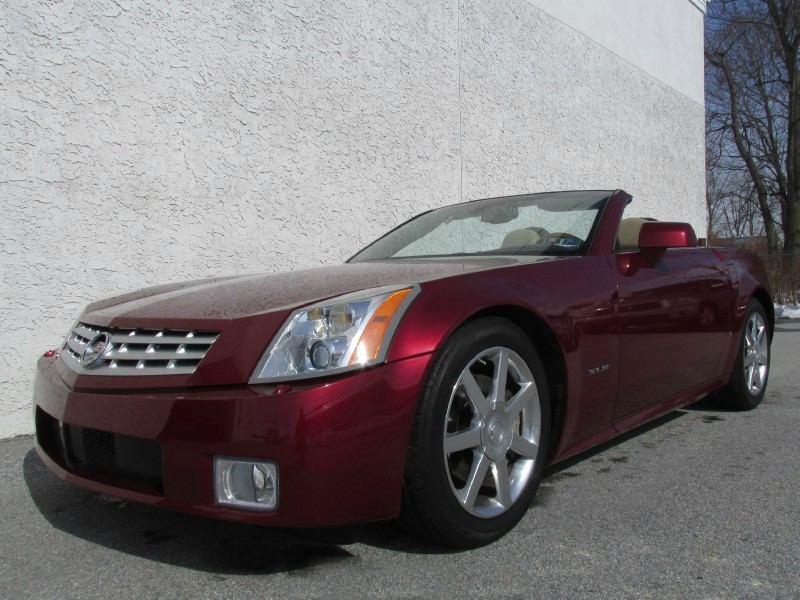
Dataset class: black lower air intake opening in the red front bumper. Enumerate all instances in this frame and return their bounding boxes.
[36,407,163,495]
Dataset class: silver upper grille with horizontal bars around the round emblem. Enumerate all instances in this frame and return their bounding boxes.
[61,323,219,375]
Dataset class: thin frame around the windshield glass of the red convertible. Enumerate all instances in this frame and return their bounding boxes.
[345,190,616,264]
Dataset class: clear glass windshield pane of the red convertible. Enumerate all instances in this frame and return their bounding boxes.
[348,192,612,262]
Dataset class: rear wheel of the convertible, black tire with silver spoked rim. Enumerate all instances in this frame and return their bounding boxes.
[724,298,772,410]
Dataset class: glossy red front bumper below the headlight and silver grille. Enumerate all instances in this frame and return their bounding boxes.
[34,355,430,527]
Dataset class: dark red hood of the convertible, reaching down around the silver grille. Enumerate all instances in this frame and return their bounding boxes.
[58,257,560,393]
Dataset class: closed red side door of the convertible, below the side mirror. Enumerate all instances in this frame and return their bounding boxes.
[614,248,731,422]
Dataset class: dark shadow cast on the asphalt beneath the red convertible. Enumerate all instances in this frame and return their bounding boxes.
[22,411,700,576]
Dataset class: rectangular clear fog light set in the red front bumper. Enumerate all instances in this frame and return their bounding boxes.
[214,456,278,510]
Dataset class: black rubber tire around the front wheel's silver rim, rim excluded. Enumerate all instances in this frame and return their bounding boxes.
[406,318,550,546]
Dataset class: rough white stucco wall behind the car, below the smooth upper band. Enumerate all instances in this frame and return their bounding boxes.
[0,0,705,437]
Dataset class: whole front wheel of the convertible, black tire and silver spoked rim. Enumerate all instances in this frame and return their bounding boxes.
[401,317,550,548]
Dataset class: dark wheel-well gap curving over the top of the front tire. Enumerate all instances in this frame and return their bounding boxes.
[456,304,567,462]
